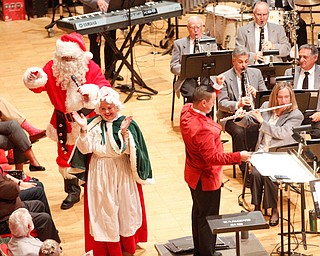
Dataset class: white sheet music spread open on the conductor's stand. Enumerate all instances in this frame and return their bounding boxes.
[250,152,316,183]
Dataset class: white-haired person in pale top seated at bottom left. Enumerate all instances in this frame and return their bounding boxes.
[8,208,42,256]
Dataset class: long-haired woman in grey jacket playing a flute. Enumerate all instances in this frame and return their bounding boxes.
[235,82,303,226]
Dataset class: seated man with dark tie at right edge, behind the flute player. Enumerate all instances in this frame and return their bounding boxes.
[285,44,320,138]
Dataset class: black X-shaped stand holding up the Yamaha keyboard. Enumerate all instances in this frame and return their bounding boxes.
[102,24,158,103]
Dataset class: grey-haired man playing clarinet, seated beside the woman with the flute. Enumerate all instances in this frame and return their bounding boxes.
[217,47,267,177]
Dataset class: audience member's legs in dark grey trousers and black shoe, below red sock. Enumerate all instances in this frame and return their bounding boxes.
[0,120,45,171]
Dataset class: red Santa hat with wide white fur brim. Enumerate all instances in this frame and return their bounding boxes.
[55,32,92,59]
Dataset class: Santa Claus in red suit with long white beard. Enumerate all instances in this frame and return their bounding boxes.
[23,33,111,209]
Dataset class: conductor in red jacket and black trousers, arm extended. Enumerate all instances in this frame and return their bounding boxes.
[180,85,250,256]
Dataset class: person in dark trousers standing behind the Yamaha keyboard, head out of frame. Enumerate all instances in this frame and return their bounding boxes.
[80,0,123,81]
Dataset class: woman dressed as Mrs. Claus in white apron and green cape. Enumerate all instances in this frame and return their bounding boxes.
[73,87,153,256]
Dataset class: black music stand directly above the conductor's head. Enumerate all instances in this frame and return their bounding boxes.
[180,50,232,80]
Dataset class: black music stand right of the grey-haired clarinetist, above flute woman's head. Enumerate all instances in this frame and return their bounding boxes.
[249,62,292,89]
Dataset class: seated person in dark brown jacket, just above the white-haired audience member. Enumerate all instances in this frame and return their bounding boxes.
[0,173,60,243]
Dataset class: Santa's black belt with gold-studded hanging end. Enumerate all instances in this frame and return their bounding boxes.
[55,108,93,154]
